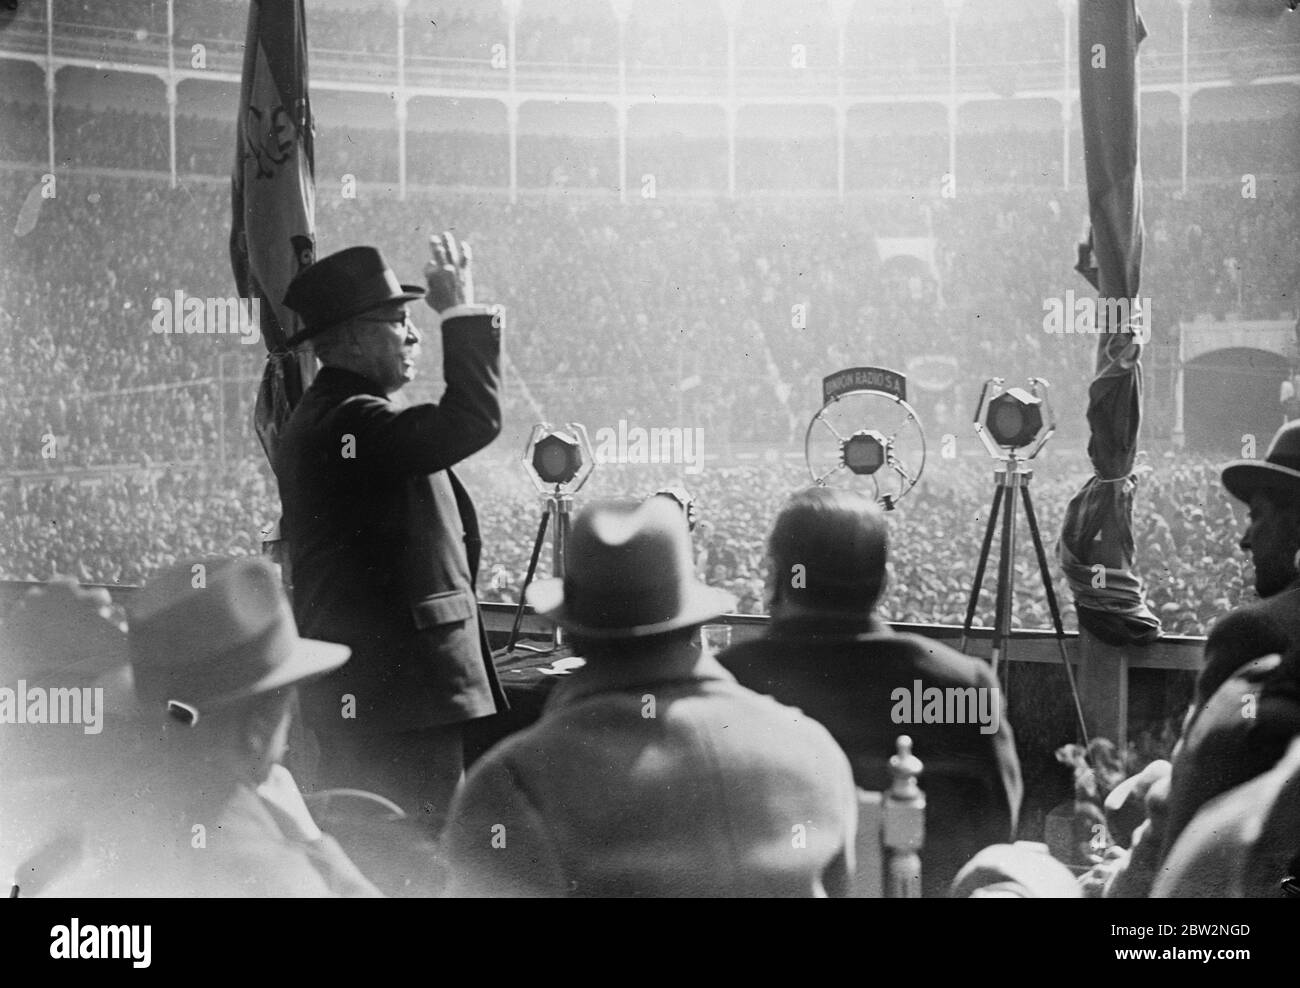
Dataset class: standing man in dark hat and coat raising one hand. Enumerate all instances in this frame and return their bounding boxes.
[274,234,507,829]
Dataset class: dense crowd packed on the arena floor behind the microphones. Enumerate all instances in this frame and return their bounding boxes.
[0,436,1251,634]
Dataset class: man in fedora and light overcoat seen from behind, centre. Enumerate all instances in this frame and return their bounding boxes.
[446,498,857,896]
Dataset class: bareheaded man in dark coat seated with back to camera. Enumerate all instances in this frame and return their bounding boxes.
[719,488,1022,896]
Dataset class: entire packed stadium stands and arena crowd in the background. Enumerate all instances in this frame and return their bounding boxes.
[0,0,1300,633]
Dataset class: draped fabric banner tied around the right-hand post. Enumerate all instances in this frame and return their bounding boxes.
[1057,0,1161,645]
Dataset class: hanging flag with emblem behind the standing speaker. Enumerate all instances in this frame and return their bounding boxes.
[230,0,316,460]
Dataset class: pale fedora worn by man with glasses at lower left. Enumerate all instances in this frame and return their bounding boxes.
[127,556,351,711]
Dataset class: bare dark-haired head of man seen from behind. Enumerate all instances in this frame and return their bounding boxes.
[767,488,889,616]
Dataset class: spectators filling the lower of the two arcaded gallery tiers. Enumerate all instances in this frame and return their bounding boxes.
[0,101,1300,196]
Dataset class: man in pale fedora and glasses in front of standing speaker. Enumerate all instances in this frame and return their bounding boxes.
[53,556,378,897]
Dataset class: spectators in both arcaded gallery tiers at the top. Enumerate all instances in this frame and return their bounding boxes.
[12,0,1300,194]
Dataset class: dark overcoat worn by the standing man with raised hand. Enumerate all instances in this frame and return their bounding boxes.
[274,312,507,733]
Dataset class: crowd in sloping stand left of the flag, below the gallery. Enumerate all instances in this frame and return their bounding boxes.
[0,178,236,469]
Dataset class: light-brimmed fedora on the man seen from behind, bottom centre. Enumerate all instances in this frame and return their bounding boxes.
[528,498,736,638]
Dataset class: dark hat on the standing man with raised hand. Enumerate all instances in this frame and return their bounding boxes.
[285,247,425,346]
